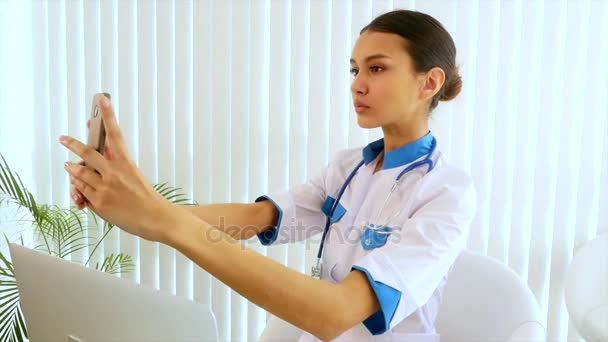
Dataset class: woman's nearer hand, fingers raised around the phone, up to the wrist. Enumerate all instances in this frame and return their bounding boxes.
[59,97,175,241]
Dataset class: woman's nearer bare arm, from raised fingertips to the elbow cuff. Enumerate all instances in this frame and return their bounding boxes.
[60,97,379,340]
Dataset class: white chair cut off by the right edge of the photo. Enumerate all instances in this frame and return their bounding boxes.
[564,233,608,342]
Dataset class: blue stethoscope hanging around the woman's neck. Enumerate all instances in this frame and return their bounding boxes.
[311,137,437,279]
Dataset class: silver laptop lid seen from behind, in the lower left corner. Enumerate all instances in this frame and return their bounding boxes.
[9,244,218,342]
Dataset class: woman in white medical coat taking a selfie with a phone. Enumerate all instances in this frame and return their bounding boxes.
[60,10,475,341]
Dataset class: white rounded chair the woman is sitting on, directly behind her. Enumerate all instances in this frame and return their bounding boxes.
[260,251,545,342]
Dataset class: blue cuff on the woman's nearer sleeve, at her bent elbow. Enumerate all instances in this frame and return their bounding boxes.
[351,265,401,335]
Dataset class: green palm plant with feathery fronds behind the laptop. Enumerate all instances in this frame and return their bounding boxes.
[0,154,196,341]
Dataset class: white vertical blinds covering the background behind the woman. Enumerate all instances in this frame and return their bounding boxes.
[0,0,608,341]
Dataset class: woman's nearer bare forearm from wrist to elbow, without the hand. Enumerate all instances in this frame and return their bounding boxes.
[158,207,379,340]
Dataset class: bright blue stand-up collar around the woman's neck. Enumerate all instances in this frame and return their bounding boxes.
[363,132,434,170]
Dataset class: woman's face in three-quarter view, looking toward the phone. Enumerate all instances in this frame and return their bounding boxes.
[350,32,429,128]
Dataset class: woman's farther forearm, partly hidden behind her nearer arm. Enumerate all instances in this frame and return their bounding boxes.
[179,201,279,240]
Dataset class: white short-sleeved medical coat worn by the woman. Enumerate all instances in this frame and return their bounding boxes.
[258,137,476,342]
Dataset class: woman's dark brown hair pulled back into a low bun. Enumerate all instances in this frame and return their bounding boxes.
[360,10,462,110]
